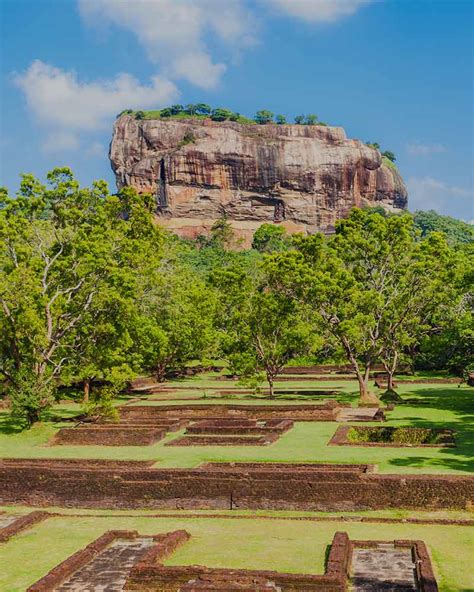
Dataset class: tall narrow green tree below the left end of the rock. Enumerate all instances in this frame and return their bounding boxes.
[62,188,165,404]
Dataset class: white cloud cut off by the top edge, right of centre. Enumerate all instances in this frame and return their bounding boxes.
[265,0,374,22]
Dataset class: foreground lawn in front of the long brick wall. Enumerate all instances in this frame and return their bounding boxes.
[0,512,474,592]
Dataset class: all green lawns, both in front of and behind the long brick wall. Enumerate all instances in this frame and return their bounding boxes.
[0,374,474,592]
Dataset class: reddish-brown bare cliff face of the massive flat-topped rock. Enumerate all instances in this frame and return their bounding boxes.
[110,115,407,244]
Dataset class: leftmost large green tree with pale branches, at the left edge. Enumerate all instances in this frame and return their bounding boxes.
[0,168,115,426]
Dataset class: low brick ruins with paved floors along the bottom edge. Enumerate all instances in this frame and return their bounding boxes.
[27,530,438,592]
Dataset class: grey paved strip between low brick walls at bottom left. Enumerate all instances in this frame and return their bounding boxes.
[55,537,154,592]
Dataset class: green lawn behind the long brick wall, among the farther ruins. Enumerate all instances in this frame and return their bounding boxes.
[0,375,474,474]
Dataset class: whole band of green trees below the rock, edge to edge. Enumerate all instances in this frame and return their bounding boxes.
[0,168,473,426]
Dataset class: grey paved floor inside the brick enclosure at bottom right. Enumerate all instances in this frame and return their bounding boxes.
[352,543,418,592]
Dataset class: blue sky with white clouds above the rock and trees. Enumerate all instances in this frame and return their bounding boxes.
[0,0,474,222]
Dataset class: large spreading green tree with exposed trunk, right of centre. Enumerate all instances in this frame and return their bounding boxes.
[267,209,454,405]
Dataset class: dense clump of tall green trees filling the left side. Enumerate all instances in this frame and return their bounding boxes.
[0,168,167,425]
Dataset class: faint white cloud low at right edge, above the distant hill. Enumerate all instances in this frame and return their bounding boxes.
[407,177,474,217]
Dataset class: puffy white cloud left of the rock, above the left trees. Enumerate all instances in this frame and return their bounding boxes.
[14,60,178,152]
